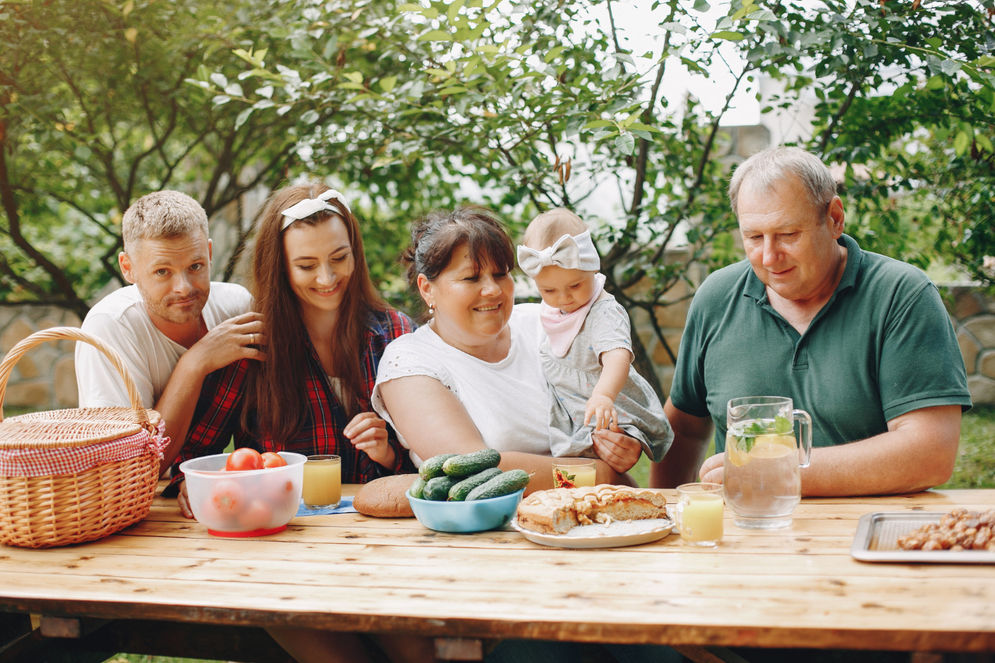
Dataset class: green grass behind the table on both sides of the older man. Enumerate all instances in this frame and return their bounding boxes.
[629,406,995,488]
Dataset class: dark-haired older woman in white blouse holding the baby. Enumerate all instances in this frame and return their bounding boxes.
[373,207,642,491]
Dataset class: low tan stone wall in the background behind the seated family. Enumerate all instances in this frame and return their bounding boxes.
[0,282,995,411]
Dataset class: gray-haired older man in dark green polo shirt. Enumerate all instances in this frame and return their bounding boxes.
[651,147,971,495]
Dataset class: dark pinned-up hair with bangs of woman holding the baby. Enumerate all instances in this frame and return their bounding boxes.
[401,205,515,314]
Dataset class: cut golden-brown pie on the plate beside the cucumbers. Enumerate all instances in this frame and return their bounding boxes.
[517,484,667,534]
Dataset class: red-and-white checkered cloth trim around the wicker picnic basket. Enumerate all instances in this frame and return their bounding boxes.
[0,421,169,477]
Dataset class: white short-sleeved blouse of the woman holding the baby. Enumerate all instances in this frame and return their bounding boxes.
[373,304,550,464]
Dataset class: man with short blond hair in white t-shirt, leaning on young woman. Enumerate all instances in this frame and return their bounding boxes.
[76,191,265,468]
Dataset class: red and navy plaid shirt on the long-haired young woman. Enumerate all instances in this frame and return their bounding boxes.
[173,309,415,483]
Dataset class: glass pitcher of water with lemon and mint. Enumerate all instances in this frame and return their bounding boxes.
[723,396,812,529]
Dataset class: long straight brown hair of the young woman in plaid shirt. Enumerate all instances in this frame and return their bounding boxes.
[242,182,386,442]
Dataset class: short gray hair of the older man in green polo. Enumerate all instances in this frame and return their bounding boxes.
[729,147,836,216]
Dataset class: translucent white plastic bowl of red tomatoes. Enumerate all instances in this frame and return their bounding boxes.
[180,449,306,537]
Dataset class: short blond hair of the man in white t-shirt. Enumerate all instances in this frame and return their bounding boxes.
[121,191,210,253]
